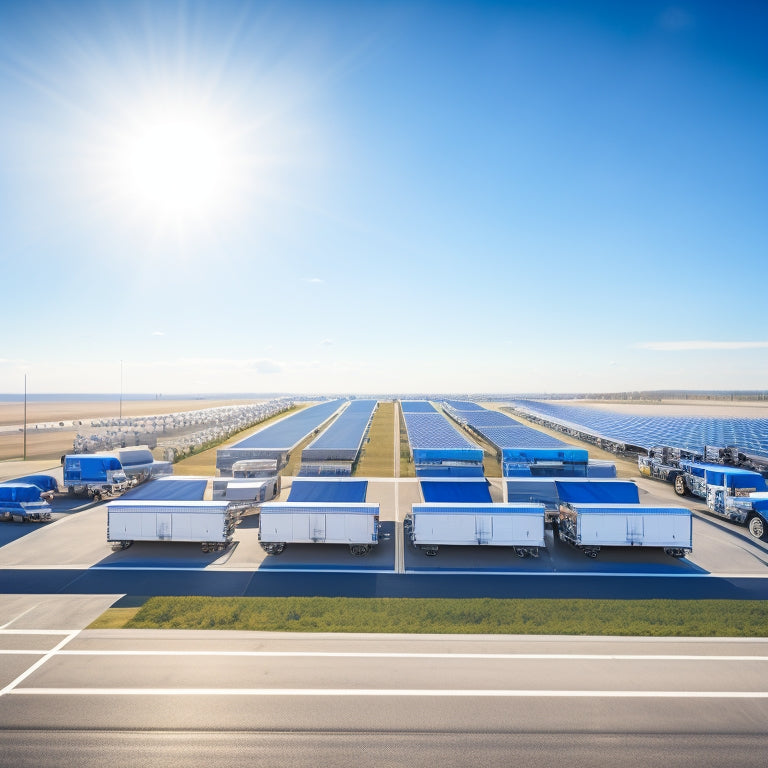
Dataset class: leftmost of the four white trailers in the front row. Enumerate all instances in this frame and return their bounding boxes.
[107,501,237,552]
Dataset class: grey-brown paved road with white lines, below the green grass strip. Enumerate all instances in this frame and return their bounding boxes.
[0,627,768,766]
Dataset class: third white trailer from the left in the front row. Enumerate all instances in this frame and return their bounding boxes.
[404,503,545,557]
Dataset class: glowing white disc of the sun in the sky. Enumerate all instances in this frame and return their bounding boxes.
[115,102,237,222]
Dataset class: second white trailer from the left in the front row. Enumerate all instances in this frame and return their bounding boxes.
[259,501,379,556]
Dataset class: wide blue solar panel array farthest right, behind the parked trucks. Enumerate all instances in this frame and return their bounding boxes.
[511,400,768,456]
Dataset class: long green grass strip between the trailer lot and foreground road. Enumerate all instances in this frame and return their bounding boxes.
[114,597,768,637]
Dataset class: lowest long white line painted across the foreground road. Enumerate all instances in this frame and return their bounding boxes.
[8,688,768,699]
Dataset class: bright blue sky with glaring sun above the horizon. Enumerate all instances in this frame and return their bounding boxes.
[0,0,768,393]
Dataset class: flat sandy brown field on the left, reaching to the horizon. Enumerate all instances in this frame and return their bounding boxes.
[0,399,256,461]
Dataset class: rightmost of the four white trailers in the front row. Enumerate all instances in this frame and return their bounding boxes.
[558,503,693,557]
